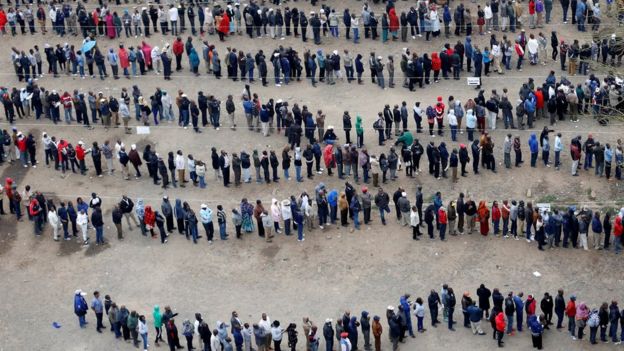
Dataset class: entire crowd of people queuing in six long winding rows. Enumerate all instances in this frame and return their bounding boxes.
[0,0,624,351]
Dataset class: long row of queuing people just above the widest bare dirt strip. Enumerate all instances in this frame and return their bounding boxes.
[0,164,624,254]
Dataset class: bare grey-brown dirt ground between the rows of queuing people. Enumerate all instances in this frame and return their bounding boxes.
[0,0,624,350]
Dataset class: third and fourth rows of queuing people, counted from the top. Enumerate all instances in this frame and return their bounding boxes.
[0,72,624,188]
